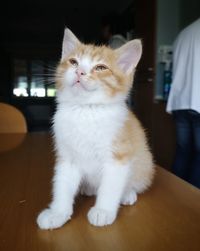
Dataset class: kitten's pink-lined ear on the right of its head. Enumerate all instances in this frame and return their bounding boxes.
[115,39,142,74]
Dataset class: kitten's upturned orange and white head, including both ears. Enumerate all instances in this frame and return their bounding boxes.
[56,29,142,104]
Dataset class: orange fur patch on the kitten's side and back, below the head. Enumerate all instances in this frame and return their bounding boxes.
[113,112,155,192]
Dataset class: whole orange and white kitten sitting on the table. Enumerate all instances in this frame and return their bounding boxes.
[37,29,154,229]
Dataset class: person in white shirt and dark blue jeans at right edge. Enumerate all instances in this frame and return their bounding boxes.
[167,18,200,188]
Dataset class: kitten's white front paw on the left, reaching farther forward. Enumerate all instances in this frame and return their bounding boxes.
[37,208,71,229]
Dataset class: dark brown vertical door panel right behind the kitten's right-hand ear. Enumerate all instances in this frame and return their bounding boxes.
[133,0,156,145]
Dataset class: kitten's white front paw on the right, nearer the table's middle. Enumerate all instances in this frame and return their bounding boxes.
[88,207,116,227]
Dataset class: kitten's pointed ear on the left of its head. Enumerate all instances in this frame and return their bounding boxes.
[61,28,80,60]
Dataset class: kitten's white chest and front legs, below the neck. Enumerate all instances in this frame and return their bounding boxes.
[38,100,134,229]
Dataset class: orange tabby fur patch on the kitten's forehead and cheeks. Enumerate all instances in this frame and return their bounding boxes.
[56,44,132,96]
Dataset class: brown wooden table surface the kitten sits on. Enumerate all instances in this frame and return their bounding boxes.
[0,134,200,251]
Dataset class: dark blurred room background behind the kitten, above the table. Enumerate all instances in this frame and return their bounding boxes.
[0,0,200,169]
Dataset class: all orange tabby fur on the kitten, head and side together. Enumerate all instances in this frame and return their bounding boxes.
[57,40,155,192]
